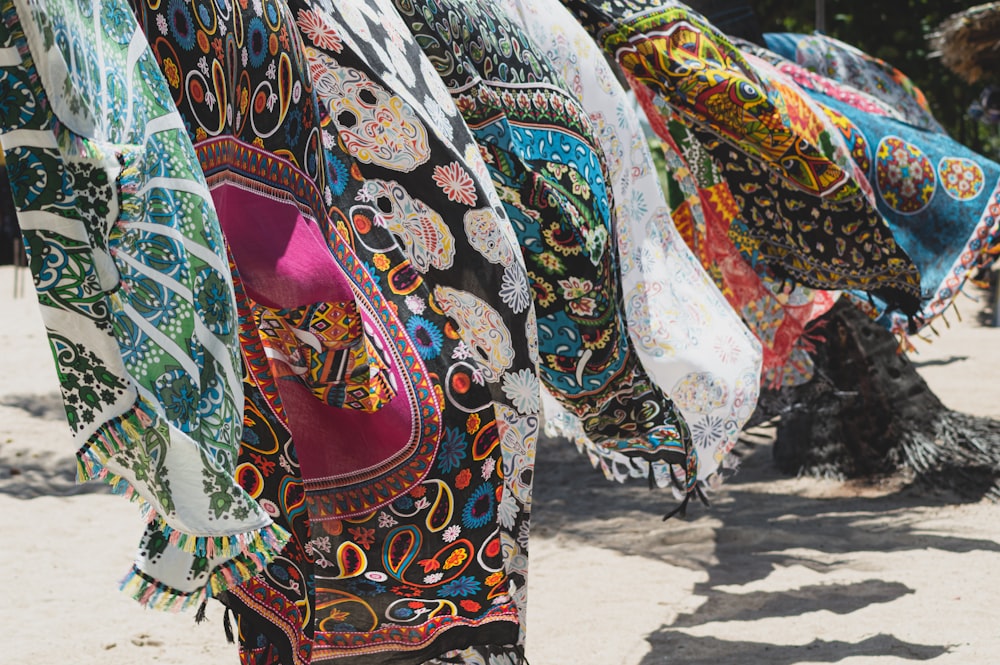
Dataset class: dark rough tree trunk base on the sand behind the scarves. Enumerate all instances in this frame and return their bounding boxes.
[755,300,1000,498]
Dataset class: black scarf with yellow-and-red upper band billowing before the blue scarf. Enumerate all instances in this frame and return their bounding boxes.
[564,0,919,314]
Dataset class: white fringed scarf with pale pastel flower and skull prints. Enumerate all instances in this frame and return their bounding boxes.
[502,0,761,485]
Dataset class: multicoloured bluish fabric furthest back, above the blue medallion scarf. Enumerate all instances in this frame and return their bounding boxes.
[764,32,945,134]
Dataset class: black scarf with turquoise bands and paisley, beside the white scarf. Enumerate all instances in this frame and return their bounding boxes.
[386,0,697,492]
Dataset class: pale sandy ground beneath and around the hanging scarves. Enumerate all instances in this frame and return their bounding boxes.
[0,267,1000,665]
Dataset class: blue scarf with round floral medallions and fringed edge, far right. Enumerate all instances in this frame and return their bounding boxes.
[754,39,1000,335]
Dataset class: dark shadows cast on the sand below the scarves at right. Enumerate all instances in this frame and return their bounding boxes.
[532,430,1000,665]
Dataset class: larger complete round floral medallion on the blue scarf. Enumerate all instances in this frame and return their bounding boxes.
[875,136,937,215]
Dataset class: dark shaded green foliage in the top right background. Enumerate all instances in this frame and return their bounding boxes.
[750,0,1000,159]
